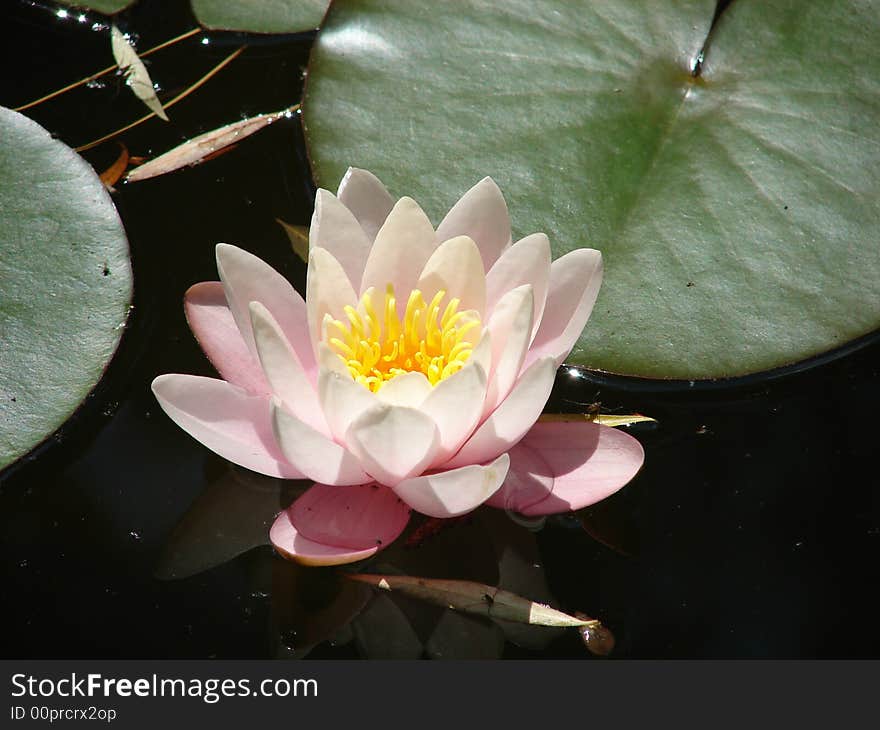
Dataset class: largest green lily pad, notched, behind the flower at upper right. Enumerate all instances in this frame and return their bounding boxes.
[303,0,880,380]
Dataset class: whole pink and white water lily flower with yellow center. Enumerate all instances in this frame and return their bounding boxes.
[153,168,644,565]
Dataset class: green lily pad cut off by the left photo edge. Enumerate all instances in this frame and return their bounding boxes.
[0,108,132,469]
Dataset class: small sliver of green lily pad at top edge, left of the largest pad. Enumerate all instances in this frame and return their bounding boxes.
[191,0,330,33]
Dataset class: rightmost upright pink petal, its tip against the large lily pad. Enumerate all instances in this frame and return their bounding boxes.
[526,248,602,366]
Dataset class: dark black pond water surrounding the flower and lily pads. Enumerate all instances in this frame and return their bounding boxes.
[0,2,880,658]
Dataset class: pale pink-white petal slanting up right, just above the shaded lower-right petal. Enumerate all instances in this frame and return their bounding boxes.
[445,357,556,469]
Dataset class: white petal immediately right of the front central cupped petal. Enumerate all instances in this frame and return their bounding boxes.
[419,352,488,464]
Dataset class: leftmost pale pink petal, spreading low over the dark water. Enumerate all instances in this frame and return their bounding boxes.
[153,374,303,479]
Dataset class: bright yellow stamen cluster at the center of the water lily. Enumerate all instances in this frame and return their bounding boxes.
[324,284,480,393]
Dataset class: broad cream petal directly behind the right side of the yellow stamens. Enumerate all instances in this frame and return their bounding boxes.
[417,236,486,317]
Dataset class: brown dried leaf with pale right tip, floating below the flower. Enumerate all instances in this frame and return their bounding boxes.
[348,573,600,627]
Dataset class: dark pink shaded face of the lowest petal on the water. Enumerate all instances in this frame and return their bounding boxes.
[287,484,410,550]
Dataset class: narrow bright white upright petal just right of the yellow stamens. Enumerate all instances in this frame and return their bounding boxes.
[484,284,534,414]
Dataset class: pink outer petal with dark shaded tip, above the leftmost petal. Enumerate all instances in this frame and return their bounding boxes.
[183,281,270,395]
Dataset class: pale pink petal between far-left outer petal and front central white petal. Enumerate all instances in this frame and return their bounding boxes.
[271,398,372,486]
